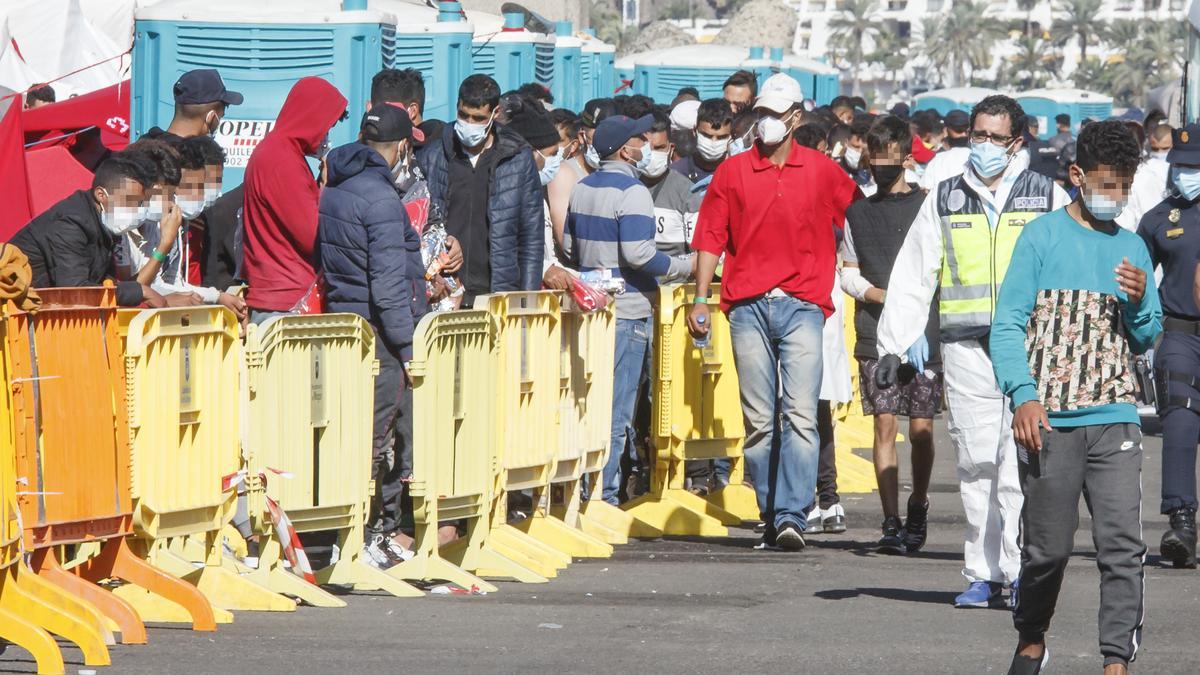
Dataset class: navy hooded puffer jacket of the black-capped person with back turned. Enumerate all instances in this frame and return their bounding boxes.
[317,143,425,360]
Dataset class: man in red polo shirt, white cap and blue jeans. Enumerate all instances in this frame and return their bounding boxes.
[688,73,862,550]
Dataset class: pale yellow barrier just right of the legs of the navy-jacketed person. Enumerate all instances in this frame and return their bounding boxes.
[388,310,546,583]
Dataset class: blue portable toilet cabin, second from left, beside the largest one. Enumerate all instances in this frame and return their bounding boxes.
[371,0,474,120]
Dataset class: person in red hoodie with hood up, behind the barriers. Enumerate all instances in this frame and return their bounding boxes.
[242,77,347,323]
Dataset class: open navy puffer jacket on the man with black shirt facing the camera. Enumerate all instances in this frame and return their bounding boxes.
[418,124,546,293]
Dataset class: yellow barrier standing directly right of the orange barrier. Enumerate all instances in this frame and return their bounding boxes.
[116,306,295,622]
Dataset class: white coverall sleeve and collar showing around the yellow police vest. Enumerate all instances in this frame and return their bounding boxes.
[877,153,1070,357]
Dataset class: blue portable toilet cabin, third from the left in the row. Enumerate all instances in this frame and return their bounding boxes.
[467,12,554,92]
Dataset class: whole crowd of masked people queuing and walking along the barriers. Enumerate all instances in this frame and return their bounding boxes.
[12,60,1200,674]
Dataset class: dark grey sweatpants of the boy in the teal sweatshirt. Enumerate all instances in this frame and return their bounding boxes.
[1013,424,1146,665]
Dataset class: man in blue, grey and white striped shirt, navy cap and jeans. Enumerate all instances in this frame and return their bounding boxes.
[563,115,692,504]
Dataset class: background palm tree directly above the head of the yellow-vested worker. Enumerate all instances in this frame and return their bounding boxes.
[924,0,1007,84]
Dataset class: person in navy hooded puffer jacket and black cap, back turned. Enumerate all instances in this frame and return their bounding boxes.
[317,106,426,568]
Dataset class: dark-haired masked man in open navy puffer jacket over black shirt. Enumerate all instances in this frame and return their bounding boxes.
[419,74,545,301]
